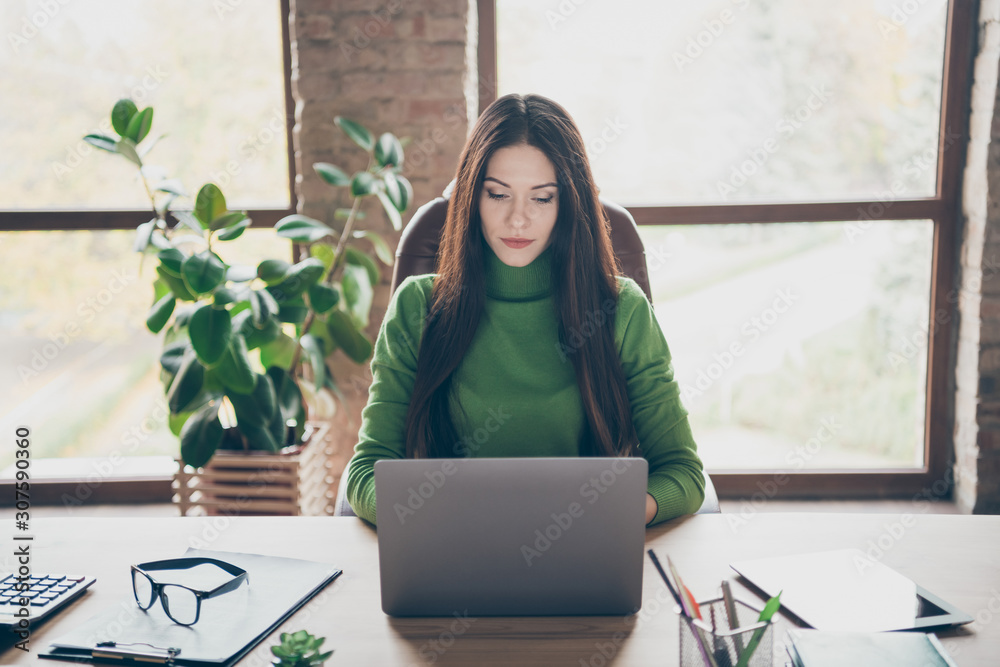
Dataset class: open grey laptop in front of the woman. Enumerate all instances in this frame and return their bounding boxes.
[375,458,648,618]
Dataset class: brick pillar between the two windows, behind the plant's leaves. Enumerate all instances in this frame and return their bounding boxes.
[289,0,478,490]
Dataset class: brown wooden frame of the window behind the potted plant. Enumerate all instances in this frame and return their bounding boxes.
[0,0,298,507]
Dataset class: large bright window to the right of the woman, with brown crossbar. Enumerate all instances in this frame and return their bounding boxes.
[488,0,975,496]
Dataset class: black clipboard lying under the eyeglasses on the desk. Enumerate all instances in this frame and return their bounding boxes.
[38,549,342,667]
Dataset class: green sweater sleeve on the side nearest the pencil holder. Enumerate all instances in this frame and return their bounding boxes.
[617,278,705,525]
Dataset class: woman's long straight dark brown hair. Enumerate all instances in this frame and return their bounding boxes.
[406,95,637,458]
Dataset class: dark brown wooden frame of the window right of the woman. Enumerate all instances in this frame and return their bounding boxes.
[477,0,978,501]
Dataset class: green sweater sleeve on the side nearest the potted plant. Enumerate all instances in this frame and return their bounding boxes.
[346,276,432,523]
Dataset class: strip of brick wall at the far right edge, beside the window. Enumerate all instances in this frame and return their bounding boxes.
[954,0,1000,513]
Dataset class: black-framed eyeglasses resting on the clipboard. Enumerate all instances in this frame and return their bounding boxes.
[132,558,249,625]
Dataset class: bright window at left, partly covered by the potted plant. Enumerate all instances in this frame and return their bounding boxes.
[0,0,294,490]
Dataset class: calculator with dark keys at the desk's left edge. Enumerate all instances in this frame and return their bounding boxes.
[0,573,97,627]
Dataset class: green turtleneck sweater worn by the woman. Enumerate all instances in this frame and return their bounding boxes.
[347,246,704,523]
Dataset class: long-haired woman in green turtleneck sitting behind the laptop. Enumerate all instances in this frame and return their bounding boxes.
[347,95,704,524]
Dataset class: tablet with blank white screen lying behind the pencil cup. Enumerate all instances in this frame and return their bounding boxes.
[730,549,972,632]
